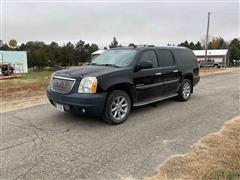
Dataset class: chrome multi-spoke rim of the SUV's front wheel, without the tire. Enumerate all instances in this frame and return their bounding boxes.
[111,96,128,121]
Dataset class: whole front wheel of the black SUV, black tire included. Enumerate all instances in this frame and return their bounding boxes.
[103,90,131,125]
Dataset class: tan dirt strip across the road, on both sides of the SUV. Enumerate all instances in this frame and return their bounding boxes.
[0,68,240,112]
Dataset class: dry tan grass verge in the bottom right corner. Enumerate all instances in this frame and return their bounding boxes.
[147,116,240,180]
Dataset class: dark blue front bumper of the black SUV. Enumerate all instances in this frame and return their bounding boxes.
[47,87,107,116]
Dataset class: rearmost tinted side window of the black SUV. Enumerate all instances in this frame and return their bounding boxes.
[175,50,197,68]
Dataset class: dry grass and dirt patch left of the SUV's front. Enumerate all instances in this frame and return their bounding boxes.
[0,70,52,112]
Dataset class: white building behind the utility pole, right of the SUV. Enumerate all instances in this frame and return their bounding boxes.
[193,49,229,66]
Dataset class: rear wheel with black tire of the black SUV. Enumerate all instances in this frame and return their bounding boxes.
[178,79,192,101]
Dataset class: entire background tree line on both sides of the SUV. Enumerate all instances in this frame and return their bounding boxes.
[0,37,240,68]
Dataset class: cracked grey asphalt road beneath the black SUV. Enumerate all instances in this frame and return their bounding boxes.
[0,72,240,180]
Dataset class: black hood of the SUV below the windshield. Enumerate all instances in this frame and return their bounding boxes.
[54,65,121,79]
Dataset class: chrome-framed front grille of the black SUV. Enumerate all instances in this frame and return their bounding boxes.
[51,76,76,94]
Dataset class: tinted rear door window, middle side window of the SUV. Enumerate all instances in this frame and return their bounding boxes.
[157,50,174,67]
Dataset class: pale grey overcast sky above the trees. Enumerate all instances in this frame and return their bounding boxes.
[2,1,239,46]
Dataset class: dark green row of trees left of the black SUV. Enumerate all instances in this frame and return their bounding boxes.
[0,40,98,68]
